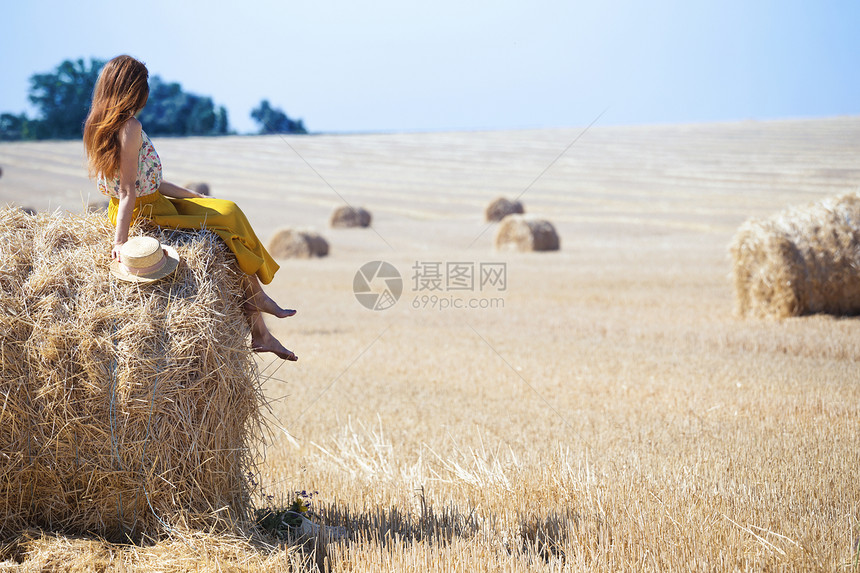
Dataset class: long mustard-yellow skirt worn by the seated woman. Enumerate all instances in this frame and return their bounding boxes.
[108,191,280,284]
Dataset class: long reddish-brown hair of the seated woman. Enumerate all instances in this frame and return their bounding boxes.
[84,56,149,179]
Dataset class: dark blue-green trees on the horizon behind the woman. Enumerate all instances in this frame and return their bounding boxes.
[0,58,307,141]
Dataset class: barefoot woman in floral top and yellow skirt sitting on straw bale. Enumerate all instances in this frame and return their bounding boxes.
[84,52,297,360]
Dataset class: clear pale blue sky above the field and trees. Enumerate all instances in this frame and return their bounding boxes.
[0,0,860,132]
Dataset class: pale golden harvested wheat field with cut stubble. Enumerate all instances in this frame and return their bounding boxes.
[0,117,860,571]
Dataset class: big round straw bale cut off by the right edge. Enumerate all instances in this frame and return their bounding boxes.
[730,194,860,318]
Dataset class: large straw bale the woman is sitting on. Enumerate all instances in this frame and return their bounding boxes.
[0,208,262,539]
